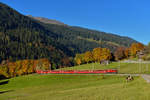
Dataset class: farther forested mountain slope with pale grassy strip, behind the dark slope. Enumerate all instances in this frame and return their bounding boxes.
[31,17,137,52]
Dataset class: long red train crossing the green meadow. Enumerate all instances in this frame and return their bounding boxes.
[36,69,118,74]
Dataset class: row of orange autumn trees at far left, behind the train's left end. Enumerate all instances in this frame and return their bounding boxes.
[0,59,51,77]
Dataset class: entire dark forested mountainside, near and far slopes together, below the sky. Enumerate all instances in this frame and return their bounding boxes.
[0,3,136,66]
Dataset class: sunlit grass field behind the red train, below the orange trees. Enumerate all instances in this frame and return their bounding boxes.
[59,62,150,74]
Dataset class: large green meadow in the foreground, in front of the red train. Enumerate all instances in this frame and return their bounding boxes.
[0,74,150,100]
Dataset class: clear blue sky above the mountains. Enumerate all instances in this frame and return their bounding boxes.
[0,0,150,44]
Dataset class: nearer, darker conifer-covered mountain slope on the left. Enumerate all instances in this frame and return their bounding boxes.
[0,3,71,64]
